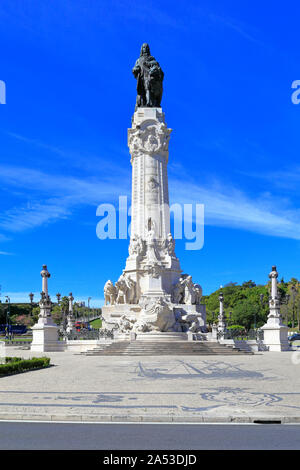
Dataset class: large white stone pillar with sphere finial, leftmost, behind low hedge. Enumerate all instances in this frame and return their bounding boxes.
[30,264,65,352]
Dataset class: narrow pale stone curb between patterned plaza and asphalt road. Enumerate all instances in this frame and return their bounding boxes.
[0,413,300,424]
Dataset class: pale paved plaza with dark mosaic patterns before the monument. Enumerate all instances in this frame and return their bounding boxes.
[0,347,300,423]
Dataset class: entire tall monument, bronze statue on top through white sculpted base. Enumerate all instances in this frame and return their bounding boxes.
[102,43,205,334]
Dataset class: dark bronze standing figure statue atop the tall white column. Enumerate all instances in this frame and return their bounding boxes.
[132,43,164,109]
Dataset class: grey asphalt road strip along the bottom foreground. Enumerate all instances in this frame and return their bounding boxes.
[0,422,300,450]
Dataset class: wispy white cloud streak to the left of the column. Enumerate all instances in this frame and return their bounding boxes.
[0,165,130,232]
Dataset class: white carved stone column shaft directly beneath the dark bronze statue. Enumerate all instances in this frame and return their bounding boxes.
[125,108,181,300]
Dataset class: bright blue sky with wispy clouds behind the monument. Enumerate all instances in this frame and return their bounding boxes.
[0,0,300,306]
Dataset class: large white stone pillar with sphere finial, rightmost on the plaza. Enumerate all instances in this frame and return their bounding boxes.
[262,266,289,351]
